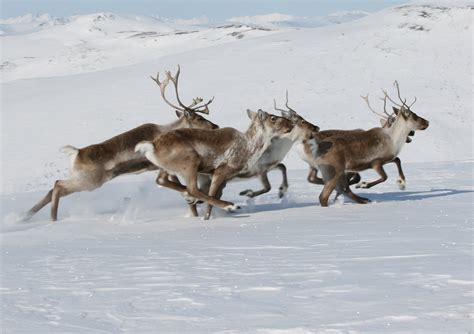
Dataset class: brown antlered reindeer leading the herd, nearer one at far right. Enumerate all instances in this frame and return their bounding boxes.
[303,81,429,206]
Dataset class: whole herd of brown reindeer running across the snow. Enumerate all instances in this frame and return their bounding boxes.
[25,65,428,221]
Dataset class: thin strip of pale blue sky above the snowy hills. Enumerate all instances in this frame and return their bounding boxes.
[0,0,409,20]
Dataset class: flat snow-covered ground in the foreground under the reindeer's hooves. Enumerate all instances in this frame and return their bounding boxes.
[0,161,474,333]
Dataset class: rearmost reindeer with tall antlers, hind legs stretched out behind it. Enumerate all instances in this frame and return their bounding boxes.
[24,65,218,221]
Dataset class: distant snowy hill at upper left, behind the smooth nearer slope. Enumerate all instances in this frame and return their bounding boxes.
[0,13,278,81]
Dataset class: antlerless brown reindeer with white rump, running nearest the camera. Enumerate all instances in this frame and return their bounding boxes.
[135,110,293,220]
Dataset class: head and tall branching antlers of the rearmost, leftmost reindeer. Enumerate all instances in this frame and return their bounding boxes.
[151,65,219,129]
